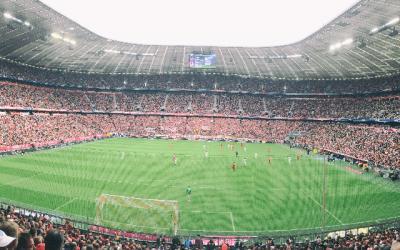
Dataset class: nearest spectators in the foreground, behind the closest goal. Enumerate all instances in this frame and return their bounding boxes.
[0,206,400,250]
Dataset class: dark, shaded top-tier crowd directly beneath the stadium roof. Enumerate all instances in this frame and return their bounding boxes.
[0,61,400,94]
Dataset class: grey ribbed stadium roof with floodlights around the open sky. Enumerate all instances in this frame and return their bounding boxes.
[0,0,400,80]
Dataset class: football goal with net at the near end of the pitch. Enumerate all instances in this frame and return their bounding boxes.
[95,194,179,235]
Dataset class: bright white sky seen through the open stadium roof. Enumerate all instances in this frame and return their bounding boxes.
[41,0,359,46]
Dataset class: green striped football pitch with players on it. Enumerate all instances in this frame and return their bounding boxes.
[0,138,400,235]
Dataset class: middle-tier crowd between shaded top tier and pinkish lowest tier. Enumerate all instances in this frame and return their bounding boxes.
[0,82,400,119]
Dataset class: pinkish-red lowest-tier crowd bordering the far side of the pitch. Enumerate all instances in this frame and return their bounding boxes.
[0,112,400,168]
